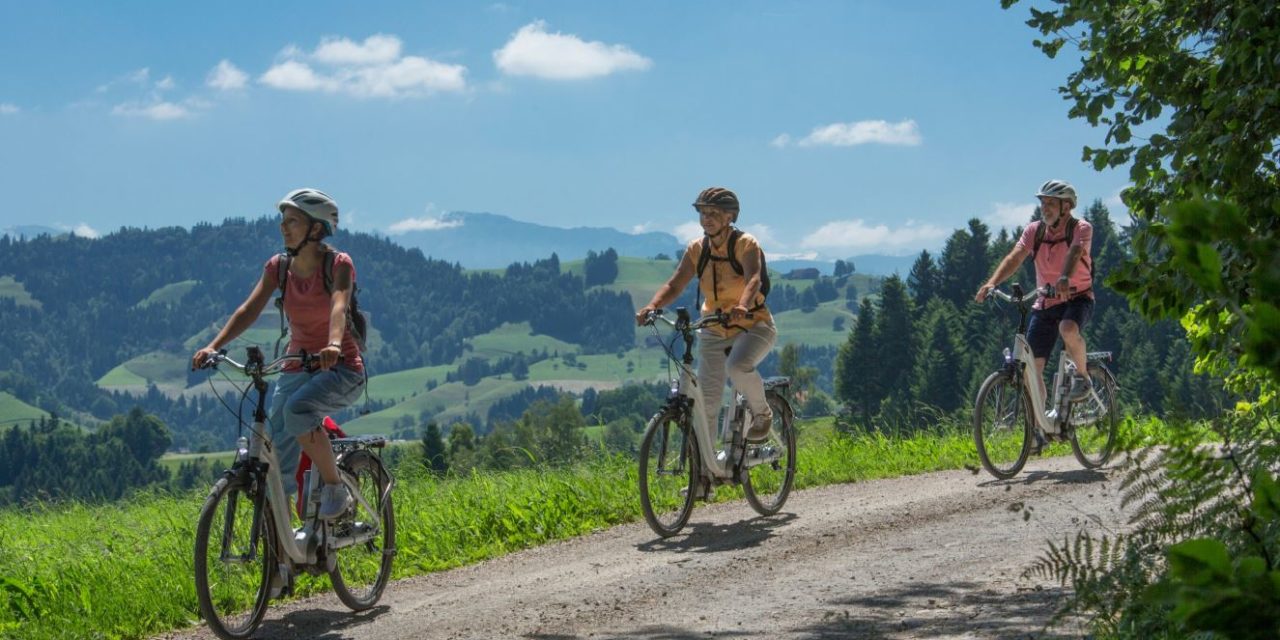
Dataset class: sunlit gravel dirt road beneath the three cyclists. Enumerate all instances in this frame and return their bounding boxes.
[165,458,1124,640]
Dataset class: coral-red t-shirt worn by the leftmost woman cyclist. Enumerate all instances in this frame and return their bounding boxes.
[262,252,365,371]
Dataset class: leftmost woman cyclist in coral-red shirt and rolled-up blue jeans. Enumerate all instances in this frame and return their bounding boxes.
[191,188,365,520]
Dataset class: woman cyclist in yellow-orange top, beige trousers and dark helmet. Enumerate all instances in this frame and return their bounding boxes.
[636,187,778,494]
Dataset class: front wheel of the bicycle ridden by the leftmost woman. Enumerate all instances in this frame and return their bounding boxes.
[195,476,275,640]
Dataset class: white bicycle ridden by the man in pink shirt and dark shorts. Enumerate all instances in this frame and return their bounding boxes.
[973,284,1119,479]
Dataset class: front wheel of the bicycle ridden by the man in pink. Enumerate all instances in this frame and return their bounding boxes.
[973,371,1032,480]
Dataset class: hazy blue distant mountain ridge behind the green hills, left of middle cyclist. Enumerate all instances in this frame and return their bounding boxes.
[389,211,681,269]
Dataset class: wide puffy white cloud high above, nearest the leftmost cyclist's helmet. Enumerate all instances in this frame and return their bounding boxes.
[259,33,467,97]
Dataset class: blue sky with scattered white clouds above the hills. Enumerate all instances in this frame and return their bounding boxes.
[0,0,1126,259]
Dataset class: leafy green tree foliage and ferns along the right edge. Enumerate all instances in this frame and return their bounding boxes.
[1002,0,1280,637]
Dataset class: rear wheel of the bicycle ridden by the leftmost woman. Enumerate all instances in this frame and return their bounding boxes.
[329,451,396,611]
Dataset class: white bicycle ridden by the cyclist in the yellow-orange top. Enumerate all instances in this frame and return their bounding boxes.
[640,307,796,538]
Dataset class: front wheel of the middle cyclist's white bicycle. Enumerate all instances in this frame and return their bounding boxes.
[640,407,701,538]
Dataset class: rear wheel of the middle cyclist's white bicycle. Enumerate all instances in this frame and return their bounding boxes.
[742,393,796,516]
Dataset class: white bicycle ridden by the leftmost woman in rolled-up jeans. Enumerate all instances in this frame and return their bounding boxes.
[195,347,396,640]
